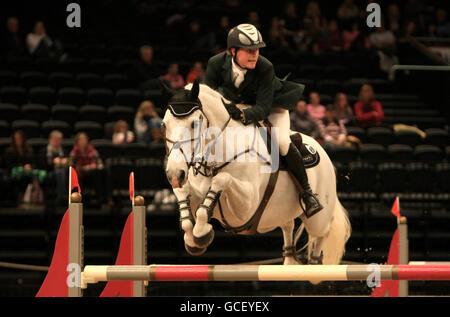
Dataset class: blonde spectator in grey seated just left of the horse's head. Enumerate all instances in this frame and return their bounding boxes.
[134,100,161,143]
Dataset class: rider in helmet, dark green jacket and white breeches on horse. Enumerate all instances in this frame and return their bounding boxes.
[205,24,323,217]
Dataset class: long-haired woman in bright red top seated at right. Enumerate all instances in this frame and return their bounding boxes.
[355,85,384,128]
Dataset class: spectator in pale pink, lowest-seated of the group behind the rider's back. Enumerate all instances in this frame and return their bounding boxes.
[318,105,347,147]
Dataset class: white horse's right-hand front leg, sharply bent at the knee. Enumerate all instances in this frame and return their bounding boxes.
[193,172,253,247]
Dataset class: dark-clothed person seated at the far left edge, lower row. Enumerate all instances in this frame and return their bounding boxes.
[5,130,35,203]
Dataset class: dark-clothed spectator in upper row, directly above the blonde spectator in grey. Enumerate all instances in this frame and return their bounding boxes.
[131,45,160,90]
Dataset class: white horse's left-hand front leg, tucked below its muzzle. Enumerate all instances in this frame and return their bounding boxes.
[173,183,206,255]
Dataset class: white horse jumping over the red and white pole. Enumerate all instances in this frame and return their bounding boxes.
[162,83,351,264]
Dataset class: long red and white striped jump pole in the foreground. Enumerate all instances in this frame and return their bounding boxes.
[81,265,450,288]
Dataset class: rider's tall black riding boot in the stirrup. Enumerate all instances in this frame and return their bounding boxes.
[285,143,323,218]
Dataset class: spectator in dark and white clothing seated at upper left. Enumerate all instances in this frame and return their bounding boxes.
[26,21,60,57]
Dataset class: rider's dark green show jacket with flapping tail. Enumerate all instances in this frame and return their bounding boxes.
[205,52,305,123]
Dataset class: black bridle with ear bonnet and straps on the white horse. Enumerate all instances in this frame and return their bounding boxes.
[163,99,270,177]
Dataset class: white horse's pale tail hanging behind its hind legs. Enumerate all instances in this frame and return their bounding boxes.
[322,198,351,264]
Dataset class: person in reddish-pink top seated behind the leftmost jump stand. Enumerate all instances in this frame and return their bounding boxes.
[70,132,106,204]
